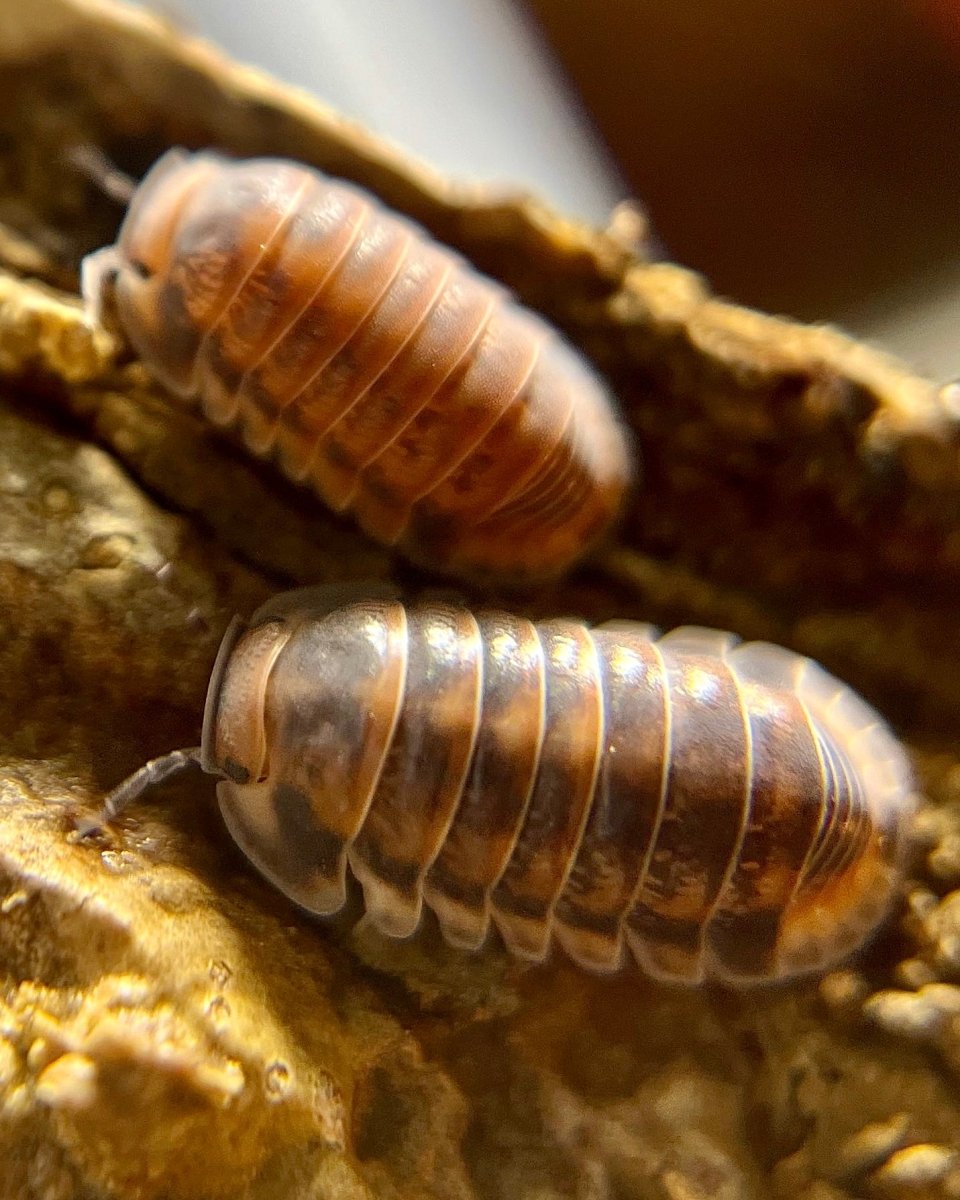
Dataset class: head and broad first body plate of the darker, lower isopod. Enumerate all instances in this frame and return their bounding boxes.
[199,583,409,907]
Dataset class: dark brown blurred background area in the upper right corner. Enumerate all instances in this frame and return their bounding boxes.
[526,0,960,371]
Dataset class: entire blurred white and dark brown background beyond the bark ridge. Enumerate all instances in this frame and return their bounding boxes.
[157,0,960,378]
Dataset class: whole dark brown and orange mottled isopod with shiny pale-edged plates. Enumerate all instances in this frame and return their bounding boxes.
[97,588,914,985]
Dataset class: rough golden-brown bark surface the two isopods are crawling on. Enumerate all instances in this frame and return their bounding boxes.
[0,0,960,1200]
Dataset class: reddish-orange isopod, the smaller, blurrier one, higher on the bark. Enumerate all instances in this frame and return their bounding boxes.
[83,150,634,578]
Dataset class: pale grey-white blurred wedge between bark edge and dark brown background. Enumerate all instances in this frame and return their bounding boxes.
[154,0,628,224]
